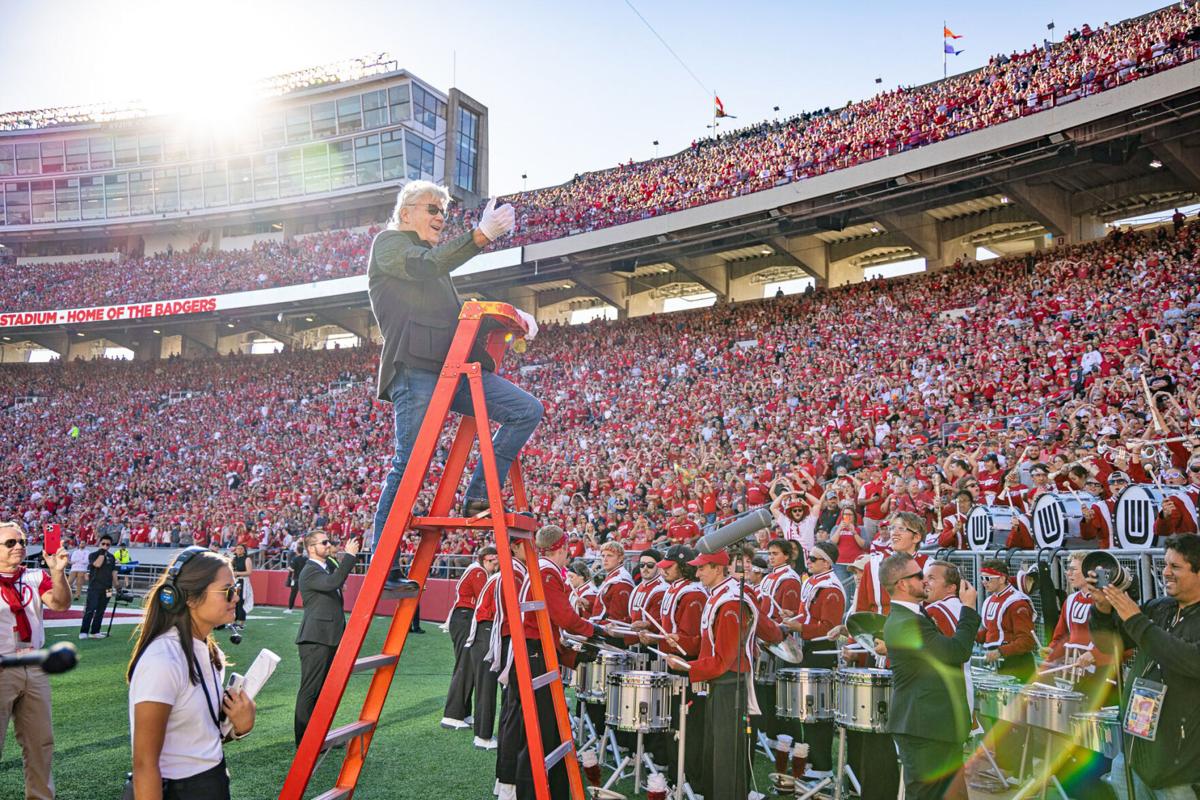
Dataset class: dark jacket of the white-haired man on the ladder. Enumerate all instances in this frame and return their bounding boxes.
[367,230,496,401]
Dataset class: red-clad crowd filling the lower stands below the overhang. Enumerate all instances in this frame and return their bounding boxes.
[0,223,1200,565]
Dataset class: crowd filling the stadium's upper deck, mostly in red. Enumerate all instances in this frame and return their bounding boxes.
[0,4,1200,311]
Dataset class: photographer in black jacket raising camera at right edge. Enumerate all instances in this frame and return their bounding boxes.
[1087,534,1200,800]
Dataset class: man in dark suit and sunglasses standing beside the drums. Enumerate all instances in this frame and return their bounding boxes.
[880,553,979,800]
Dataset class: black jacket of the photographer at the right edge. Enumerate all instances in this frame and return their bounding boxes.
[1090,597,1200,789]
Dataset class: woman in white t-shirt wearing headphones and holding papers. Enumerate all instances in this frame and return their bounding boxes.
[126,547,254,800]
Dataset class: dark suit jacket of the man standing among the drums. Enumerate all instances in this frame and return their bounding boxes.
[883,603,979,742]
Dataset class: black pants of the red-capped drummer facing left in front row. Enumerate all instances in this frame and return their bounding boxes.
[689,673,751,800]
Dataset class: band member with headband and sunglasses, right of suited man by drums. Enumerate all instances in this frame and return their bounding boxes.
[978,559,1038,682]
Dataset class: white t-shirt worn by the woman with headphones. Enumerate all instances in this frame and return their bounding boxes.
[130,628,224,780]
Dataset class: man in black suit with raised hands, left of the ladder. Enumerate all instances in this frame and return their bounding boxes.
[295,530,360,747]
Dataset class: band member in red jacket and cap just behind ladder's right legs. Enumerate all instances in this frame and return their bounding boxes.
[497,525,602,800]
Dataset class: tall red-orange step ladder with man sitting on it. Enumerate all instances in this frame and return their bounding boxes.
[280,302,584,800]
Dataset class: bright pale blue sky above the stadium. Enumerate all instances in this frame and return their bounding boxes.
[0,0,1163,192]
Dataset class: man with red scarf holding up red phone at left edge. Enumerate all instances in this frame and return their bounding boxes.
[0,521,71,800]
